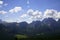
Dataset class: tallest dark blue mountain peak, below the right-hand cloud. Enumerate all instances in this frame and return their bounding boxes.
[42,18,57,32]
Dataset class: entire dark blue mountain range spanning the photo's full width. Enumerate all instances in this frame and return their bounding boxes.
[0,18,60,38]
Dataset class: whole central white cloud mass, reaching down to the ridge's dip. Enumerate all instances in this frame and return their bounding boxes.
[20,9,42,23]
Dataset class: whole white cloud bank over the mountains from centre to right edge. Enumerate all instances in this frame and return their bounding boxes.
[20,9,60,23]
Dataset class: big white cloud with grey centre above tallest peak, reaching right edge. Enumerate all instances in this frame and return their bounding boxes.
[43,9,60,21]
